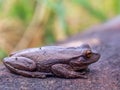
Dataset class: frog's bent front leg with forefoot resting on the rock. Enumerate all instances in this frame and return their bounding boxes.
[52,64,87,78]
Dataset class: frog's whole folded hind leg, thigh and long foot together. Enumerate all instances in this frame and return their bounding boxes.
[3,57,51,78]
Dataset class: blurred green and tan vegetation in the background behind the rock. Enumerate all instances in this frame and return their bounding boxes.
[0,0,120,59]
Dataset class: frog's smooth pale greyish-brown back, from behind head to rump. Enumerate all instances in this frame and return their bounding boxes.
[13,46,82,61]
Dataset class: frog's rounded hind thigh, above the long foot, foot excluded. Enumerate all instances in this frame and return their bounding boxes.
[3,57,36,71]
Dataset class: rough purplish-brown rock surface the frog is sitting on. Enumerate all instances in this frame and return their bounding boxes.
[0,17,120,90]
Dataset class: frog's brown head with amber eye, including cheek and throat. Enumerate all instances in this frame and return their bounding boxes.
[70,44,100,70]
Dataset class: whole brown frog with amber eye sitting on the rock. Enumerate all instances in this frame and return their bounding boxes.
[3,44,100,79]
